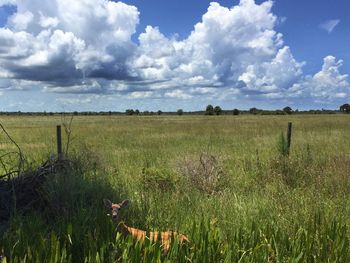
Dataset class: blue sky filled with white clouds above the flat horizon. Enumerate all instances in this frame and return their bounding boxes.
[0,0,350,111]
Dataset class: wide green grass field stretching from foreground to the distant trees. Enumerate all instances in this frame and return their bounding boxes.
[0,115,350,262]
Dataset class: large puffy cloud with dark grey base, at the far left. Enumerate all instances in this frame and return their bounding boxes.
[0,0,139,86]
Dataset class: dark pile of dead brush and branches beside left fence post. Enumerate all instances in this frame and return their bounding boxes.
[0,123,70,223]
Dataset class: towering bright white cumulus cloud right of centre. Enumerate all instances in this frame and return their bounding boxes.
[131,0,303,98]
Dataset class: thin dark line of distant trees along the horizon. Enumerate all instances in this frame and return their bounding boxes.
[0,103,350,116]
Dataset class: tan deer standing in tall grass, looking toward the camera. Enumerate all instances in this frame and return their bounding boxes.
[103,199,189,256]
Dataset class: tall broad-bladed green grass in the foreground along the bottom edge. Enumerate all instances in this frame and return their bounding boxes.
[1,214,350,263]
